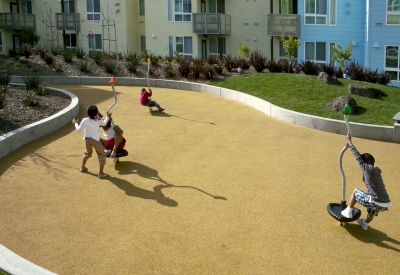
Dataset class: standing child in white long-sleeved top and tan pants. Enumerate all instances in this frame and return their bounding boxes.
[72,105,111,179]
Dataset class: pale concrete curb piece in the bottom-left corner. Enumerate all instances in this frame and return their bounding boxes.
[0,244,56,275]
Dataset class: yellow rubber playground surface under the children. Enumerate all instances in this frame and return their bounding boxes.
[0,86,400,275]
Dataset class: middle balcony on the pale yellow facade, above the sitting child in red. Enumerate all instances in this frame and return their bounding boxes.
[192,13,231,34]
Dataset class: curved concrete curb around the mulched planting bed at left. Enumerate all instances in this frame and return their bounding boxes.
[0,83,79,161]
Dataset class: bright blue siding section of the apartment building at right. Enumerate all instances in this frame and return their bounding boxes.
[288,0,400,86]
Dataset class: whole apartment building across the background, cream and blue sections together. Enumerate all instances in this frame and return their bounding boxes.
[0,0,400,86]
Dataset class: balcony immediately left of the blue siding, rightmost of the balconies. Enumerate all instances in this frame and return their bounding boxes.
[267,14,300,37]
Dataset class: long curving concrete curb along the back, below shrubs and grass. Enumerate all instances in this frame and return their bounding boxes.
[9,76,400,143]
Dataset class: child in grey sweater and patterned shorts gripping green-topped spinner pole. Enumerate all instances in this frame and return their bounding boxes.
[341,134,392,230]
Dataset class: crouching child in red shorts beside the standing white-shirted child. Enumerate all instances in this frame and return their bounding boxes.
[100,114,126,158]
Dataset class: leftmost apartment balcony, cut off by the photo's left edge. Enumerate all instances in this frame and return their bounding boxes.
[0,13,36,30]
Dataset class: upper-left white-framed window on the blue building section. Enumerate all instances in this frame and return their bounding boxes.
[304,0,328,25]
